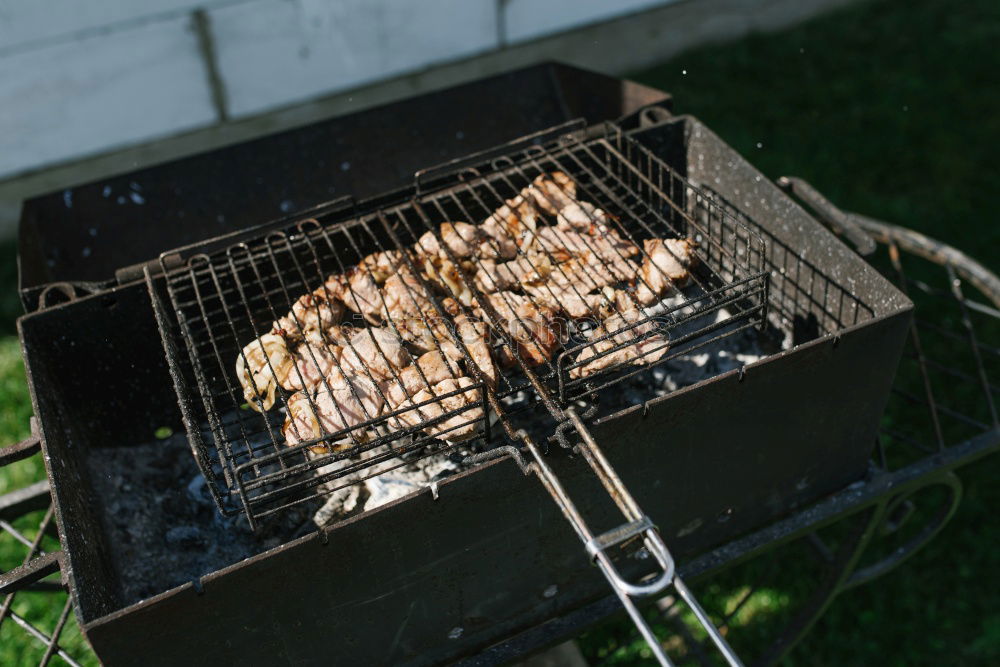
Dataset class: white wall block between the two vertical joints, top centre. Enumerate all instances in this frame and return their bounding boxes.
[216,0,498,116]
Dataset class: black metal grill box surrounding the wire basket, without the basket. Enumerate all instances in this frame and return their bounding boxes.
[18,65,911,665]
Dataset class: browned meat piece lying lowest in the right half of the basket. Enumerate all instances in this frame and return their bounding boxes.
[570,309,669,378]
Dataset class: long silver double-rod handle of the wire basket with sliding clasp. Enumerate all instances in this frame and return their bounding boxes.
[517,408,742,666]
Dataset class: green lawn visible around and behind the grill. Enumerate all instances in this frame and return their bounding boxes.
[0,0,1000,665]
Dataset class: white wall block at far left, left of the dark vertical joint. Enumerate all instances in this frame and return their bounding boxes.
[0,16,216,177]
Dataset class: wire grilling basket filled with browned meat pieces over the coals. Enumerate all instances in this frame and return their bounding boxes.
[150,127,767,524]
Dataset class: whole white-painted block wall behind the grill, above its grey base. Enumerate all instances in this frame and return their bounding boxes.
[0,0,684,181]
